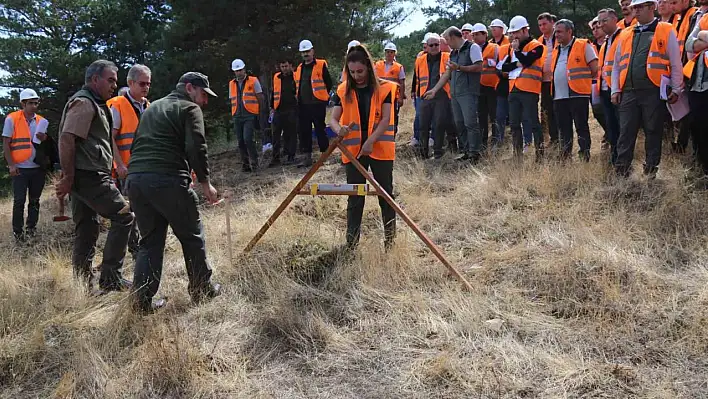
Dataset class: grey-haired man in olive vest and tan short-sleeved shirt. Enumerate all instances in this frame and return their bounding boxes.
[56,60,133,293]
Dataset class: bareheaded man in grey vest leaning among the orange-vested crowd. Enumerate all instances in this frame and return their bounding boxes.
[424,26,483,163]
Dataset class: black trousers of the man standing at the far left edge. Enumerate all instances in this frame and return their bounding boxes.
[12,168,46,235]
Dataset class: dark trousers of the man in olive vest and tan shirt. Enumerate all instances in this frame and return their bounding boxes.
[71,170,133,289]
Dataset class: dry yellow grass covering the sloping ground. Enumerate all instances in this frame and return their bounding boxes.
[0,107,708,398]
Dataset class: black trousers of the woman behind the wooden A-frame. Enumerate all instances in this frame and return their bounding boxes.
[345,157,396,247]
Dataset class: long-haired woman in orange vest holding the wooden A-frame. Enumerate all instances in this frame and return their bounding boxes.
[330,45,396,248]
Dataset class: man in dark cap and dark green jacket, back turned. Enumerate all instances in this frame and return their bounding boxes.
[128,72,221,313]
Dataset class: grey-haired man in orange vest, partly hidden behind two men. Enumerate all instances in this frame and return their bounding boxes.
[106,64,152,260]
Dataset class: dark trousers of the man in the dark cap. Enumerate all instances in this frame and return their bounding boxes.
[128,173,211,306]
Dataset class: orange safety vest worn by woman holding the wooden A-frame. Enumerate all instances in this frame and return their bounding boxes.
[337,79,396,163]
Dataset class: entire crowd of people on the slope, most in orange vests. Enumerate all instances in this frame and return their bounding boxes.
[3,0,708,312]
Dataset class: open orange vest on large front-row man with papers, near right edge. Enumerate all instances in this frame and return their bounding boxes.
[617,22,673,89]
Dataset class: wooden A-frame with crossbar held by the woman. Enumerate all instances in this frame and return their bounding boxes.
[244,137,472,291]
